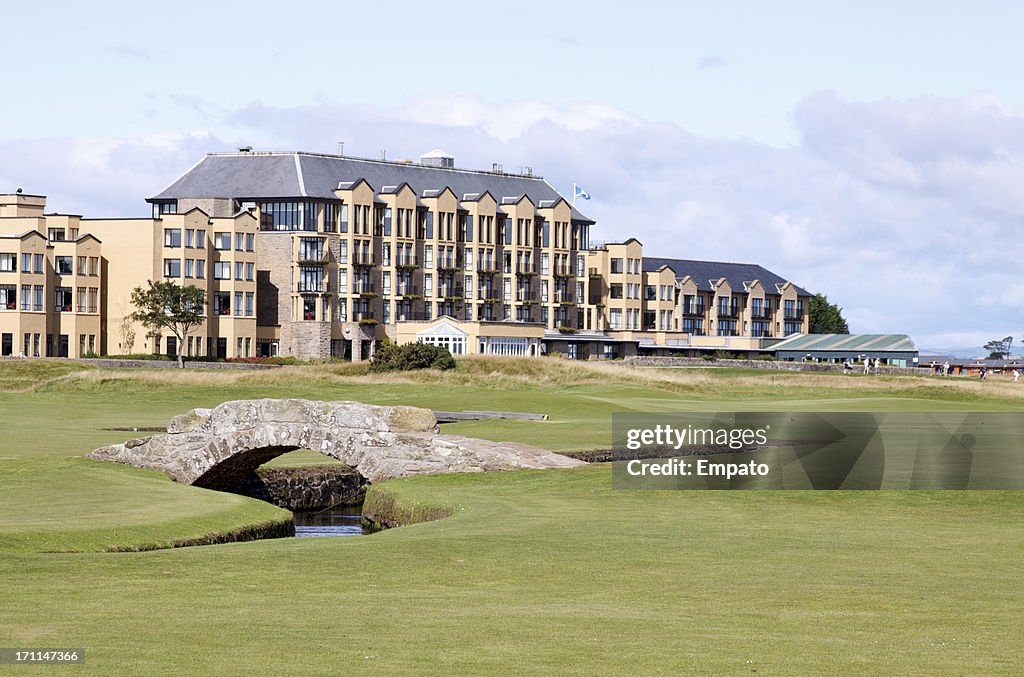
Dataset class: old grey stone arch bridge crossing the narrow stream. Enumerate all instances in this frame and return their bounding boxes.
[88,399,583,491]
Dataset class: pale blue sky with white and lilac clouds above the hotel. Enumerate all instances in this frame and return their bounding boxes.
[0,0,1024,353]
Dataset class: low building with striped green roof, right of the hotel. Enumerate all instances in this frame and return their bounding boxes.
[773,334,918,367]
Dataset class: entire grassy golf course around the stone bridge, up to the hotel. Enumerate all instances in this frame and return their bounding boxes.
[0,359,1024,675]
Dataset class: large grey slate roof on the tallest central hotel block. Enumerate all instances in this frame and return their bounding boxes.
[148,152,594,223]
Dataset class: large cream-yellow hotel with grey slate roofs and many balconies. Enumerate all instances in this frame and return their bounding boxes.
[0,149,809,361]
